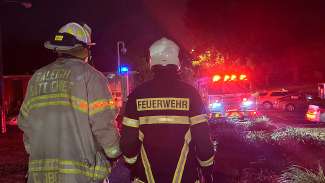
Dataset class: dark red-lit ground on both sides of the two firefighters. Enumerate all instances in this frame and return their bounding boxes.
[0,111,325,183]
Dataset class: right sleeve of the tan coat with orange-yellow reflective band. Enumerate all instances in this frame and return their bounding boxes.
[87,71,121,158]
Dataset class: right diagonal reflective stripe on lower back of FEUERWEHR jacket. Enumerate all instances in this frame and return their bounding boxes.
[172,130,192,183]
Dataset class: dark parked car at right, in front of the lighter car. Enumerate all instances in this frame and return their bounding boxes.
[274,93,320,112]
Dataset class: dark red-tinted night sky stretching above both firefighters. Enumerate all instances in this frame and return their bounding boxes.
[1,0,325,82]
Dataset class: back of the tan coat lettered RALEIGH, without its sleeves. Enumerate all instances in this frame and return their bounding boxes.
[21,59,108,182]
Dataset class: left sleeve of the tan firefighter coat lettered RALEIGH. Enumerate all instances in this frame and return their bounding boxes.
[18,80,31,154]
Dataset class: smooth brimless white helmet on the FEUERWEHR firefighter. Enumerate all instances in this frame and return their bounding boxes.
[149,37,180,68]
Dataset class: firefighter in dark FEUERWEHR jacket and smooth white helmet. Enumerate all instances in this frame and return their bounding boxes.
[120,38,214,183]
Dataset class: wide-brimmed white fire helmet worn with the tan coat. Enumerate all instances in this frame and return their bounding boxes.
[44,22,95,51]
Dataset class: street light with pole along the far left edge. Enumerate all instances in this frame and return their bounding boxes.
[0,0,32,133]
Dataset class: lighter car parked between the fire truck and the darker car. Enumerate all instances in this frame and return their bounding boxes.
[258,89,289,109]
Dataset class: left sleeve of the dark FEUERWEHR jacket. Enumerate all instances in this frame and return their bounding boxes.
[121,93,141,165]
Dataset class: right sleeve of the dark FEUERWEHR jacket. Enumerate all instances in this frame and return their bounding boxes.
[190,92,214,167]
